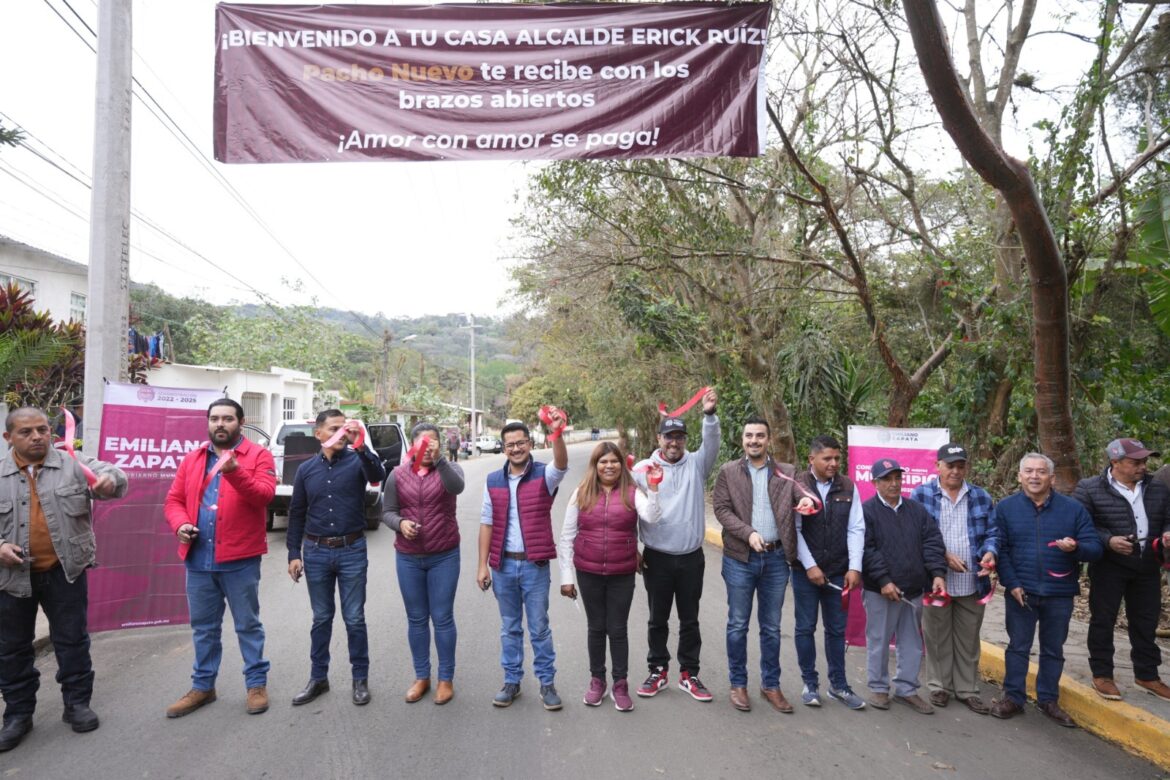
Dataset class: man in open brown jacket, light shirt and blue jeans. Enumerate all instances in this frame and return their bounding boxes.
[711,417,814,712]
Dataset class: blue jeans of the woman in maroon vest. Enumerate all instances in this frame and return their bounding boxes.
[394,547,459,681]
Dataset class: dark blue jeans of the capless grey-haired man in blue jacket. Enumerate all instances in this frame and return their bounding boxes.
[1004,593,1073,706]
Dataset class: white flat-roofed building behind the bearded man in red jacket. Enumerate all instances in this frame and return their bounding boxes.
[146,363,321,435]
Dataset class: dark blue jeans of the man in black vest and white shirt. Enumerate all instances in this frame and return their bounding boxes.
[792,570,849,690]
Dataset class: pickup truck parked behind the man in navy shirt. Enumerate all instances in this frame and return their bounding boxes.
[260,420,406,531]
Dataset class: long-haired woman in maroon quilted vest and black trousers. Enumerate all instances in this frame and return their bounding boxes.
[557,442,662,712]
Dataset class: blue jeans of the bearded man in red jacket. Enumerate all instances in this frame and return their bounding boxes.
[187,555,269,691]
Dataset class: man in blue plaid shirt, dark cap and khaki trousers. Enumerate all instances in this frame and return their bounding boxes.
[910,443,996,715]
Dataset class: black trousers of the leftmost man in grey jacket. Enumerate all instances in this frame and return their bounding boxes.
[0,565,94,722]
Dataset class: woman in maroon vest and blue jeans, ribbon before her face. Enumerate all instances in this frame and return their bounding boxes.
[381,422,463,704]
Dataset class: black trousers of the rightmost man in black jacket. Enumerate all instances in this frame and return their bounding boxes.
[1088,560,1162,681]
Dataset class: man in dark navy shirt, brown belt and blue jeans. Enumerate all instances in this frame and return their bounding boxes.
[285,409,386,705]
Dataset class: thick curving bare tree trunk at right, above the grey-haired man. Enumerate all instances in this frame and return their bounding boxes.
[902,0,1081,491]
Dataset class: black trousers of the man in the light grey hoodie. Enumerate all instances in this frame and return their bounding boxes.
[642,547,707,677]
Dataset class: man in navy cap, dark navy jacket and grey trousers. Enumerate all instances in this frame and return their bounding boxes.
[861,457,947,715]
